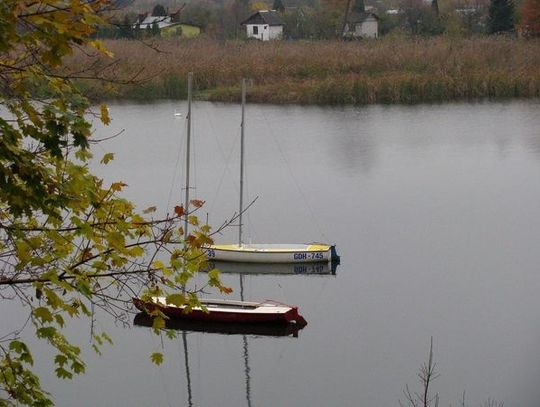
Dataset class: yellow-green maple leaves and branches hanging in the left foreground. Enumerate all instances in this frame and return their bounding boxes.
[0,0,228,406]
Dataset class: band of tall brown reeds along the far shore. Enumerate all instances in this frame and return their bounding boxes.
[68,38,540,104]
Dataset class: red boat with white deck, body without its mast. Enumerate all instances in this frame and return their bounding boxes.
[133,297,307,326]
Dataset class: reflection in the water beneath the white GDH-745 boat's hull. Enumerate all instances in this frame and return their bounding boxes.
[208,261,338,276]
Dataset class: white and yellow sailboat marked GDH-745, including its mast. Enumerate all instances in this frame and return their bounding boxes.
[207,79,339,264]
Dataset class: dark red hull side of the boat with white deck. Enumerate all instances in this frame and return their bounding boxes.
[133,298,307,325]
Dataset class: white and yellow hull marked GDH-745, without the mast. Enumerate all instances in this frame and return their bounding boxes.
[206,244,338,264]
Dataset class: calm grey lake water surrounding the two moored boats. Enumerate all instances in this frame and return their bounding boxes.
[1,101,540,407]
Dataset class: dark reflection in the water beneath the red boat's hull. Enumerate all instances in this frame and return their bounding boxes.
[133,312,304,338]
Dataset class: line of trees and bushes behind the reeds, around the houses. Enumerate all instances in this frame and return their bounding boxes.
[97,0,540,40]
